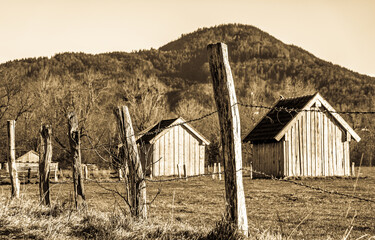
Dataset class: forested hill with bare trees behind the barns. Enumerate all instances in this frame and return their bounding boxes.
[0,24,375,167]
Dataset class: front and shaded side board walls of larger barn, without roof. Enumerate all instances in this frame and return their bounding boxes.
[253,104,350,176]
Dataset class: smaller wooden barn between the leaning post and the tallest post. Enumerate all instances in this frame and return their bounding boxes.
[137,117,210,176]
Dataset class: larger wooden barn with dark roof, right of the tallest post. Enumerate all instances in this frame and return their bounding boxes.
[243,93,361,177]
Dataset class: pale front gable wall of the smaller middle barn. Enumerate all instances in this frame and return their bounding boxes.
[152,126,205,176]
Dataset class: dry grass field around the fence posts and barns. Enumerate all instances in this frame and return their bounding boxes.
[0,168,375,239]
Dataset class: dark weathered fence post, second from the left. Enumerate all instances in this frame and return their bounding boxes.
[39,125,52,206]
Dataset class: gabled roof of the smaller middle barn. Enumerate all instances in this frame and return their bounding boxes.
[137,117,210,145]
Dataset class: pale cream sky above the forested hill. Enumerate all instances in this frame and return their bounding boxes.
[0,0,375,76]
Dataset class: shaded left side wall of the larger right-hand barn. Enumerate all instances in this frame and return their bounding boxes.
[253,141,284,177]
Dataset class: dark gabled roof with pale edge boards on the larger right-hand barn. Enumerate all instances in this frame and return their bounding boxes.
[243,93,361,142]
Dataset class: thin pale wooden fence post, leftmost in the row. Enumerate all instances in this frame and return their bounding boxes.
[7,120,20,198]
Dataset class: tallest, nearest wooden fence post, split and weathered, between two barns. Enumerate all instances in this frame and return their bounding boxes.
[207,43,248,236]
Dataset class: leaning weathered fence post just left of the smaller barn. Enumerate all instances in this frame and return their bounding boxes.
[115,106,147,219]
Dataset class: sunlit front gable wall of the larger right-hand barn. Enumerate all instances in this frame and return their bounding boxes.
[284,108,350,176]
